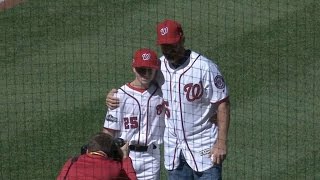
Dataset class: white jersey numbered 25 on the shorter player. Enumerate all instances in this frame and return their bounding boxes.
[104,84,164,146]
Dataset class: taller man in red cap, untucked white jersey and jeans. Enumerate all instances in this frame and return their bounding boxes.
[106,20,230,180]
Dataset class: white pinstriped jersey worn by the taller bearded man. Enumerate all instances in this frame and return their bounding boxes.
[158,51,228,171]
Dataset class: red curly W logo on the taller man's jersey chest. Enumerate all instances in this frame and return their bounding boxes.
[183,81,203,102]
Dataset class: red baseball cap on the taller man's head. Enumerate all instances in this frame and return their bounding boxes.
[157,19,183,44]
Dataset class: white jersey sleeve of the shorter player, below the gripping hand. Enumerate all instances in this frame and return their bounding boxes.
[103,93,123,130]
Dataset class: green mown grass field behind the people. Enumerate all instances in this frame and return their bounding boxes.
[0,0,320,180]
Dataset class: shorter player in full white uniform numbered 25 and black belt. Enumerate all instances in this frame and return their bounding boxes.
[103,48,164,180]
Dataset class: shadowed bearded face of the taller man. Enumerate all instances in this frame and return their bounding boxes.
[160,43,184,63]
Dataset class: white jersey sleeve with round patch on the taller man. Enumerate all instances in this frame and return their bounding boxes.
[204,63,229,103]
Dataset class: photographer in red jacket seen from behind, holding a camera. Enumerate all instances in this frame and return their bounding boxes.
[57,132,137,180]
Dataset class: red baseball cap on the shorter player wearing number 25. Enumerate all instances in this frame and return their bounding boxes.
[132,48,160,70]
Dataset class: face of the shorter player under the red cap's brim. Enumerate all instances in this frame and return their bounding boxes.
[133,67,157,85]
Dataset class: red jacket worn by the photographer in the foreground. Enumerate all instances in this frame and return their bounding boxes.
[57,154,137,180]
